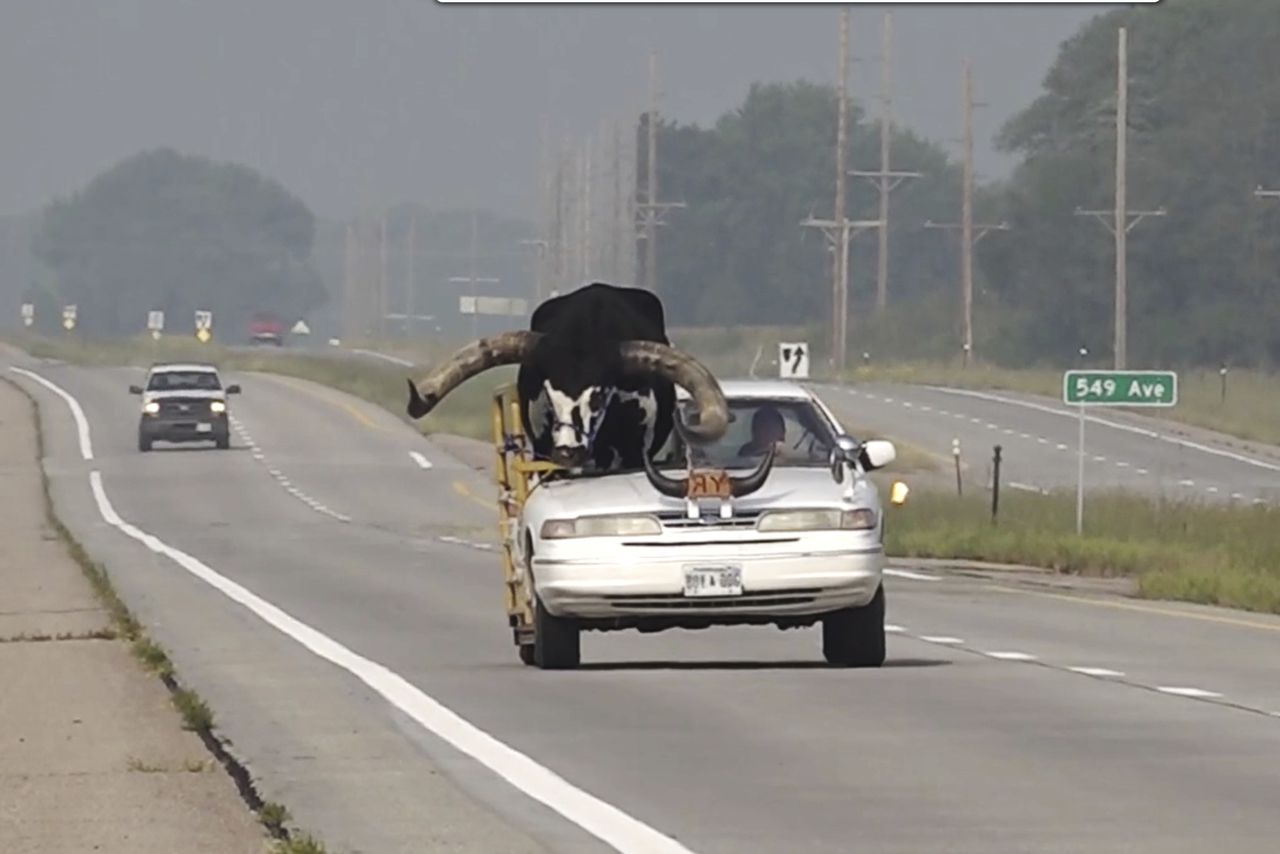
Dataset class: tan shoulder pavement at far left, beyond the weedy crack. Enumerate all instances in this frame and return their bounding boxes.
[0,382,270,854]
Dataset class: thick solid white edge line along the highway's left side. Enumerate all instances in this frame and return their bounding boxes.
[2,368,692,854]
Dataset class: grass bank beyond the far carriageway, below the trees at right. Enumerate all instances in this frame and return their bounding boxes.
[846,362,1280,444]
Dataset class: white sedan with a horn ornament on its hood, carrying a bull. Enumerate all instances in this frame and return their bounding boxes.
[509,380,895,668]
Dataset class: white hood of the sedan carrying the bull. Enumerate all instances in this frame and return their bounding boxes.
[530,466,876,516]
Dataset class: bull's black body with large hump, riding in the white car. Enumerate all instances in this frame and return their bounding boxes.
[516,283,676,471]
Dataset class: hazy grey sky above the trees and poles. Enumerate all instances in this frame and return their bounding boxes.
[0,0,1110,224]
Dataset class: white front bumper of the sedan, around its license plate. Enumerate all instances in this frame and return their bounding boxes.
[532,544,884,625]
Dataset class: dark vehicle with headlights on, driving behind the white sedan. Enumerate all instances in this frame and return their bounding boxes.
[129,362,239,451]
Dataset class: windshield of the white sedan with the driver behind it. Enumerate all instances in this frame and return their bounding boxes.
[657,398,835,469]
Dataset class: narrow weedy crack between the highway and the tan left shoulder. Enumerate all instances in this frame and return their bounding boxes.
[0,378,326,854]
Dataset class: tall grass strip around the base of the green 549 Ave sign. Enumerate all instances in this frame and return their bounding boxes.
[886,493,1280,613]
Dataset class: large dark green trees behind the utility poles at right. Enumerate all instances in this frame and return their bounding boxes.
[650,0,1280,365]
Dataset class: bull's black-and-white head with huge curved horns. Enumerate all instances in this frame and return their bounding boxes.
[408,330,728,466]
